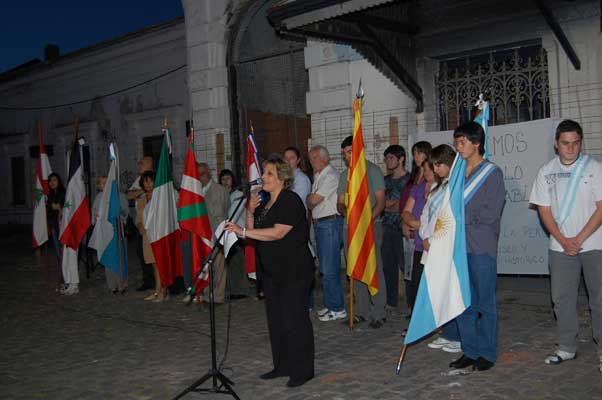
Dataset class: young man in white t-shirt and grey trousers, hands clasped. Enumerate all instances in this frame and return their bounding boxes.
[529,120,602,372]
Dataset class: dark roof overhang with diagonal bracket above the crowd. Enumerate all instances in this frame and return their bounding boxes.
[268,0,423,112]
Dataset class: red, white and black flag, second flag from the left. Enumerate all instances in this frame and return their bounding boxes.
[60,139,90,250]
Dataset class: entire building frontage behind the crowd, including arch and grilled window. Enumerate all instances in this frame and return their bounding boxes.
[0,0,602,227]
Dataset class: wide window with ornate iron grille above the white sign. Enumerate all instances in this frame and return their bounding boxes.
[435,44,550,130]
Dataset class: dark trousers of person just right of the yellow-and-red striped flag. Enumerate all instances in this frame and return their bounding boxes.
[381,224,404,307]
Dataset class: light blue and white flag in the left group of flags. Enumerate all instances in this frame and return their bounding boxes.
[89,144,127,281]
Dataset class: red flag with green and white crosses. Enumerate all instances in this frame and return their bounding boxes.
[178,129,211,293]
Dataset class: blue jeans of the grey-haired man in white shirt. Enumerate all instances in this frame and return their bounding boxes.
[314,218,345,311]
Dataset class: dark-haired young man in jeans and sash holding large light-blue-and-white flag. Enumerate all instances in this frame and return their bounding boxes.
[450,122,506,371]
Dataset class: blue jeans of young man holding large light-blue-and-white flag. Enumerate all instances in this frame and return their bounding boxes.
[456,254,498,362]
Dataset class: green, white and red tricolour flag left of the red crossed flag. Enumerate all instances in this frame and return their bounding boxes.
[144,128,182,287]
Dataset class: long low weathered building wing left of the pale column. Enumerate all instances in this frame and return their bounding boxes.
[0,18,190,224]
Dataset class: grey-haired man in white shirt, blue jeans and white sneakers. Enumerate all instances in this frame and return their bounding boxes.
[307,146,347,321]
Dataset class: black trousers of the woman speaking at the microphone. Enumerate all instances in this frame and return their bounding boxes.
[261,275,314,382]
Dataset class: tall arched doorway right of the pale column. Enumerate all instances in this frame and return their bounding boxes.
[228,0,311,177]
